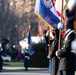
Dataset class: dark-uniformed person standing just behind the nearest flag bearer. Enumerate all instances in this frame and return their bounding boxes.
[49,29,59,75]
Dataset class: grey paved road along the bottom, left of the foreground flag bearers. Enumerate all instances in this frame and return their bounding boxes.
[0,70,50,75]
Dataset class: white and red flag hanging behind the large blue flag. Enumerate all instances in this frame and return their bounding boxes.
[55,0,66,21]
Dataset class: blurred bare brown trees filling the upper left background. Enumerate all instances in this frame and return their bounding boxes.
[0,0,37,44]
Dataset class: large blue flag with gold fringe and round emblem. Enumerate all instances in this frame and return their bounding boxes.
[35,0,60,28]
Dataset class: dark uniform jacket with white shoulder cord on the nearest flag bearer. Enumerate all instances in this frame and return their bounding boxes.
[58,30,75,70]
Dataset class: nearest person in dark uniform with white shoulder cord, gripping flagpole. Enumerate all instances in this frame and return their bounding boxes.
[56,3,76,75]
